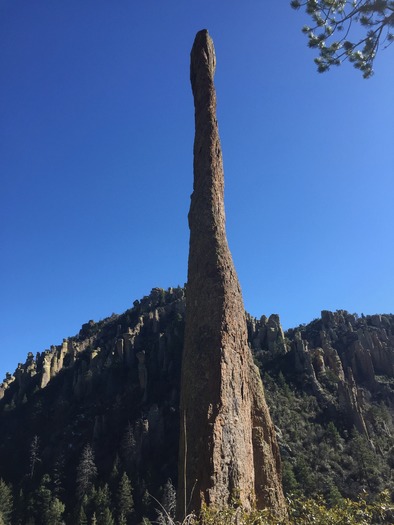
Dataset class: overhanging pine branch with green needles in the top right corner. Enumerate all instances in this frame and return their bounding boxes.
[290,0,394,78]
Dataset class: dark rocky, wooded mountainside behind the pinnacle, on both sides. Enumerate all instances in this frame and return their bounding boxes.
[0,288,394,525]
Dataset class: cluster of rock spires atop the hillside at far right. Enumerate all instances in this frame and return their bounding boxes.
[286,310,394,439]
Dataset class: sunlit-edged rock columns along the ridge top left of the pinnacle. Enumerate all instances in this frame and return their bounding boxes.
[0,287,185,410]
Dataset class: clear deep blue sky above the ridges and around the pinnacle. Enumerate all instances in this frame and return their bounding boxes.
[0,0,394,377]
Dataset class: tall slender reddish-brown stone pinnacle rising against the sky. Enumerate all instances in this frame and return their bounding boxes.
[177,30,286,518]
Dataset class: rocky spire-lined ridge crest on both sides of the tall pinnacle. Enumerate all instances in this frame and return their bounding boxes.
[0,296,394,448]
